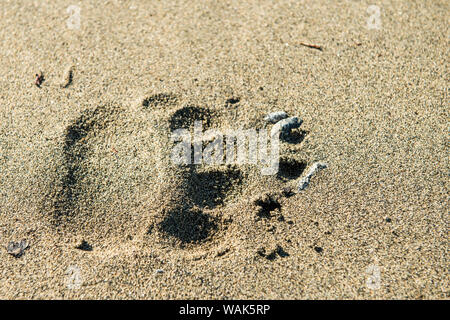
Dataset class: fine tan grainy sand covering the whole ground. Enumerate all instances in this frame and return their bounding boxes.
[0,0,450,299]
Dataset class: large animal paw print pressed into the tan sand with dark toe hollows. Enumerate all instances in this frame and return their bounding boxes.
[43,93,306,254]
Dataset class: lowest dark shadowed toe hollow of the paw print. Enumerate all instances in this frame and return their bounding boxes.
[159,208,217,244]
